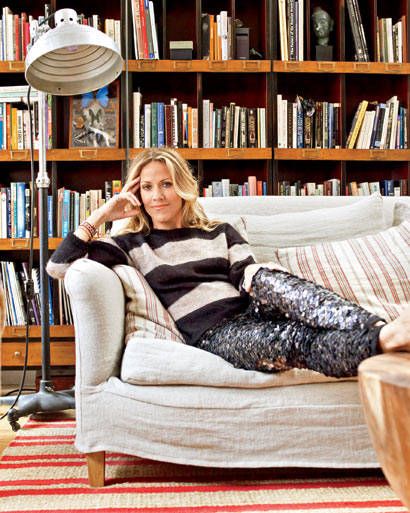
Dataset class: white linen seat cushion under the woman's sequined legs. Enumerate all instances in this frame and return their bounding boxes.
[121,337,340,388]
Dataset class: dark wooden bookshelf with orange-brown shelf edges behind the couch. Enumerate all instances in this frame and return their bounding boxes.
[0,0,410,370]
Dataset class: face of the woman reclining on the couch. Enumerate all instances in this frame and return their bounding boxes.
[140,160,183,230]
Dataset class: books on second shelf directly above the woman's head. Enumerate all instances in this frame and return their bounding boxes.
[133,92,198,148]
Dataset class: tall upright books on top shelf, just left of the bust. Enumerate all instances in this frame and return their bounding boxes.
[278,0,304,61]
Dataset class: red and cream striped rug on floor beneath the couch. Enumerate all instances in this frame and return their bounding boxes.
[0,418,407,513]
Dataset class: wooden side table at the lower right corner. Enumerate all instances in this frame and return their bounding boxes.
[359,353,410,509]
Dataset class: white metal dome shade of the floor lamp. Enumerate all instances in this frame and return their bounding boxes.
[25,9,123,96]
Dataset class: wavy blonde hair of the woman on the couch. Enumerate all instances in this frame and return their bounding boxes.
[119,148,219,233]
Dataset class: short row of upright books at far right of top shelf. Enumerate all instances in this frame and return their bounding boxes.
[376,15,407,62]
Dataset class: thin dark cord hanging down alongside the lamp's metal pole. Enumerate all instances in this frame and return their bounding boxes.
[0,85,34,420]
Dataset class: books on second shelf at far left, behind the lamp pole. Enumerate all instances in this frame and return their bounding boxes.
[0,85,52,150]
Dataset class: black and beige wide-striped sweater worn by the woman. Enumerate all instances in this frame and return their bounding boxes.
[47,223,255,345]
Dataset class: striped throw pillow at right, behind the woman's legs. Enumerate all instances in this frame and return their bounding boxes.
[275,221,410,321]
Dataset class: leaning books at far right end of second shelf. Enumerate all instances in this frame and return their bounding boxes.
[346,96,408,150]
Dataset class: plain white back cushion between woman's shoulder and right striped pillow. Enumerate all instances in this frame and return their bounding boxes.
[239,194,386,262]
